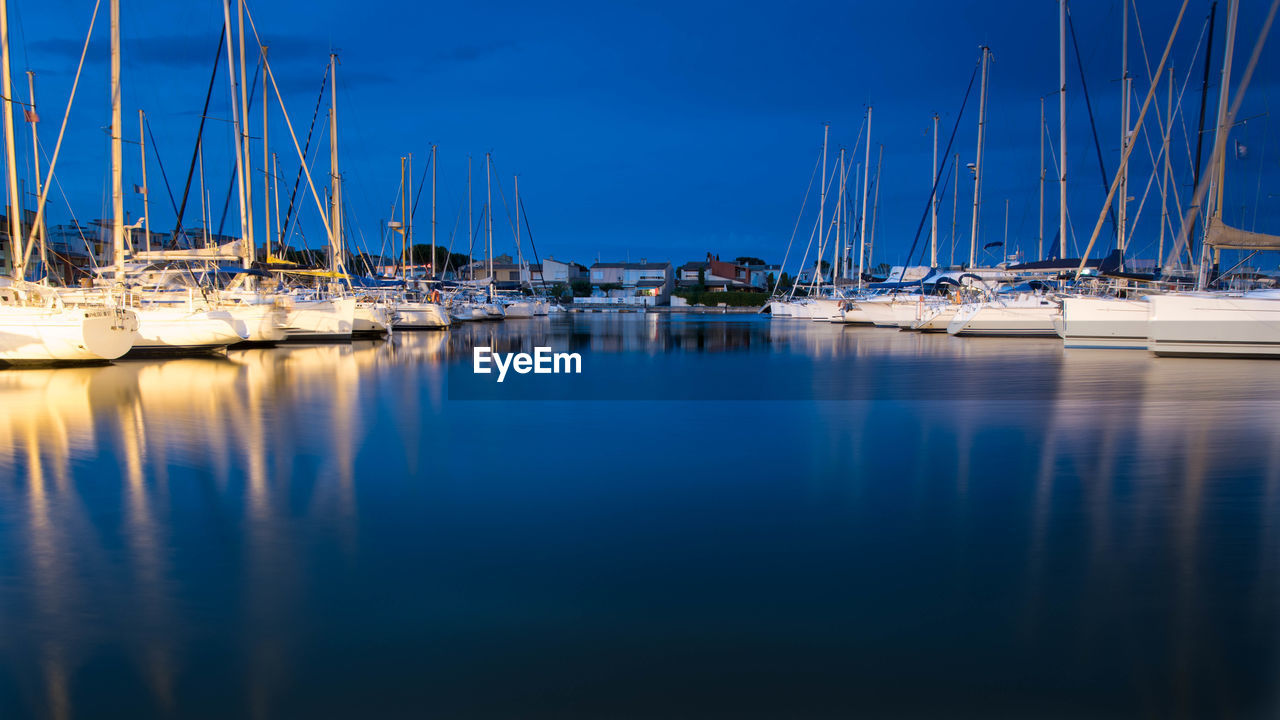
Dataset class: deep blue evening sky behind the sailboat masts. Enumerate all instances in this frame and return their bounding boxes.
[10,0,1280,269]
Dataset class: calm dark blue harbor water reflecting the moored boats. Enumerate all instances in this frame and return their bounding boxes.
[0,315,1280,719]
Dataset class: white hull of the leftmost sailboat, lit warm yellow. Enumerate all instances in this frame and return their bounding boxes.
[0,306,138,365]
